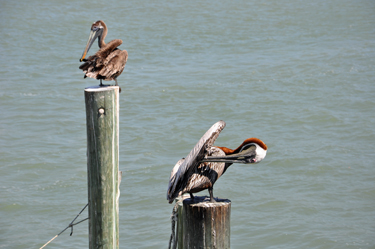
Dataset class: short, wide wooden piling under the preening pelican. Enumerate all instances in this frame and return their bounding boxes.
[177,196,231,249]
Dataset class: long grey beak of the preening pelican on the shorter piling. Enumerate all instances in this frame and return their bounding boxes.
[201,146,263,164]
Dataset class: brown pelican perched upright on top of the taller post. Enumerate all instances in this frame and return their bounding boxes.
[79,20,128,86]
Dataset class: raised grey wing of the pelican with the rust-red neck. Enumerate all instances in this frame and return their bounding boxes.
[167,121,225,203]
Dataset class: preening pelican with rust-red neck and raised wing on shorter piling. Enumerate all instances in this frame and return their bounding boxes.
[167,121,267,203]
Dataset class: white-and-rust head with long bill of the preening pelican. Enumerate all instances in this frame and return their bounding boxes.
[202,138,267,164]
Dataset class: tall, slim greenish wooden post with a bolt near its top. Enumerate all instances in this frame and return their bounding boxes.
[85,86,121,249]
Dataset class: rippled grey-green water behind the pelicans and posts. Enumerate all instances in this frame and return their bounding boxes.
[0,0,375,248]
